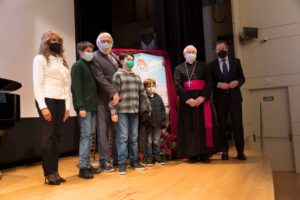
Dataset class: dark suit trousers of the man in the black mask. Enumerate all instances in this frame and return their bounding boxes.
[215,94,244,154]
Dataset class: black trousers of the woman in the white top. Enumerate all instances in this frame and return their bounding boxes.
[36,98,65,176]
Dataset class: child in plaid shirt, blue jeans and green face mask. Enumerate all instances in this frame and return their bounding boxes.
[110,53,149,175]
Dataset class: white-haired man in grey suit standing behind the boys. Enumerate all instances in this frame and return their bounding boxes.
[91,32,120,172]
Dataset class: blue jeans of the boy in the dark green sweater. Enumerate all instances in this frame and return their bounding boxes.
[78,112,96,168]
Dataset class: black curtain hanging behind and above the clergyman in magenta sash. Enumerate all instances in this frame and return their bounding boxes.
[155,0,205,70]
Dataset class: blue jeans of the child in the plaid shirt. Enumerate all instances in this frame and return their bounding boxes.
[116,113,139,164]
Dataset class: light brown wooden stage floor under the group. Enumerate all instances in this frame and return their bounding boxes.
[0,151,274,200]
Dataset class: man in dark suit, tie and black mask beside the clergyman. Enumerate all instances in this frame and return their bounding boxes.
[209,41,247,160]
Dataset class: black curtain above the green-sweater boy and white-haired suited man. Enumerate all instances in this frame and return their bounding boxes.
[74,0,112,51]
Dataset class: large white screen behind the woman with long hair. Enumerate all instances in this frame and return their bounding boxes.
[0,0,76,117]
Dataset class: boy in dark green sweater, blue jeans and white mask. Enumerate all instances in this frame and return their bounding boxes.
[71,41,101,179]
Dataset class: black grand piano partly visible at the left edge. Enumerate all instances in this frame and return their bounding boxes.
[0,78,22,180]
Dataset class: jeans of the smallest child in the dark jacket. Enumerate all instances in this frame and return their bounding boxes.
[146,126,160,157]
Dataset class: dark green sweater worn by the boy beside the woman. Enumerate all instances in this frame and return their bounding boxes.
[71,59,97,112]
